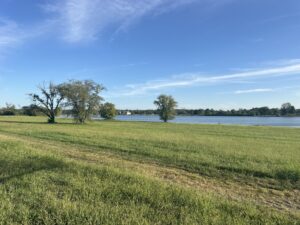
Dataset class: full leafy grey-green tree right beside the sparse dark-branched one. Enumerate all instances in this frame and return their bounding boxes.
[60,80,105,123]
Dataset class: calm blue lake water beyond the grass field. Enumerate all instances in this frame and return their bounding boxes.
[112,115,300,127]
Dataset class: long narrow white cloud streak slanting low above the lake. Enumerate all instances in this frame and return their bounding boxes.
[118,63,300,96]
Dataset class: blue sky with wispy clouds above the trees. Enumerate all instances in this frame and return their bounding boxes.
[0,0,300,109]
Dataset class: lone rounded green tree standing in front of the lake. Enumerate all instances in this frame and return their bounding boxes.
[154,95,177,122]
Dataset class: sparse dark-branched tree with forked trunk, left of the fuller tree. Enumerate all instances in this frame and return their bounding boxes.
[29,82,64,123]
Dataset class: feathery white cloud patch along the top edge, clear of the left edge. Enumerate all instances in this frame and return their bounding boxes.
[43,0,204,42]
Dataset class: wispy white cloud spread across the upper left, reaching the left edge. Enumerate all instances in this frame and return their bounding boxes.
[0,0,232,48]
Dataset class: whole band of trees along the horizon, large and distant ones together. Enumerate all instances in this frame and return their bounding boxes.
[0,80,300,123]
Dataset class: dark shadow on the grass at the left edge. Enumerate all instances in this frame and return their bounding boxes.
[0,156,65,185]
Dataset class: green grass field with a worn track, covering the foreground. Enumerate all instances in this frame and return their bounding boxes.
[0,117,300,225]
